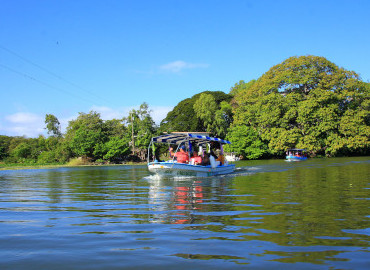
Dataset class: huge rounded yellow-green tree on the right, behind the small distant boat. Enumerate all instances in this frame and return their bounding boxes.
[233,56,370,156]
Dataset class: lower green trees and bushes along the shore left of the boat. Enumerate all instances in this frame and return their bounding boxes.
[0,103,156,164]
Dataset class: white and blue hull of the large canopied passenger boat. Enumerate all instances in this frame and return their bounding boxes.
[148,162,235,177]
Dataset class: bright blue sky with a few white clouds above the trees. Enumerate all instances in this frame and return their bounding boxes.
[0,0,370,137]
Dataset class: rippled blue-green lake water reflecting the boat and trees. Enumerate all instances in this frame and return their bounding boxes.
[0,157,370,269]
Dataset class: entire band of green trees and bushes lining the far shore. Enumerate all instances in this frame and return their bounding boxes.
[0,56,370,165]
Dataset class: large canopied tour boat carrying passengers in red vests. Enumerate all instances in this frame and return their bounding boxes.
[148,132,235,177]
